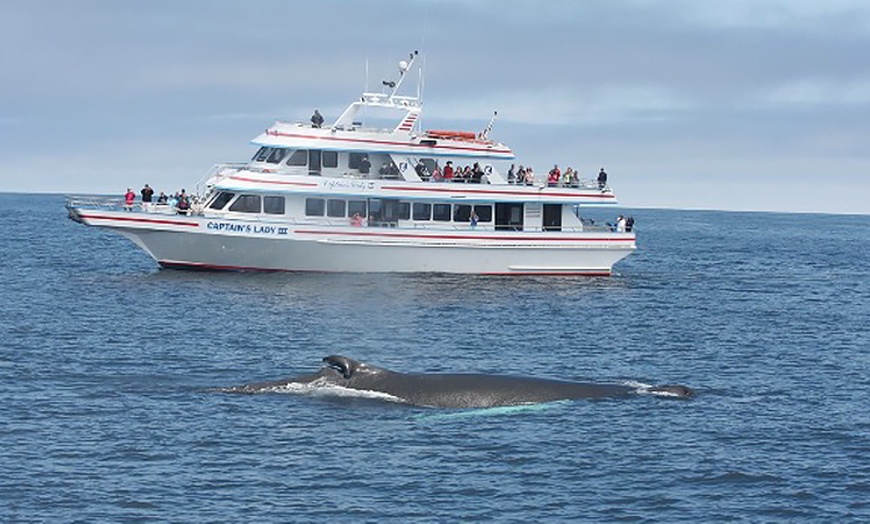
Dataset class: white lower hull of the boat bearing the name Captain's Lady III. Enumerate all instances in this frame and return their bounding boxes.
[77,211,635,276]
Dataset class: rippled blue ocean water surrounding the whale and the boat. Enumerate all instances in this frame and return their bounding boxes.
[0,194,870,522]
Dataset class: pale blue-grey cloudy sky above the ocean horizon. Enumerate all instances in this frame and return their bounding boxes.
[0,0,870,214]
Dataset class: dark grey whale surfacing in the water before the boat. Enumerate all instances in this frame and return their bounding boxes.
[222,355,695,408]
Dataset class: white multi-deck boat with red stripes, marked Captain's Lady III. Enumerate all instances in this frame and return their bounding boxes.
[67,52,636,275]
